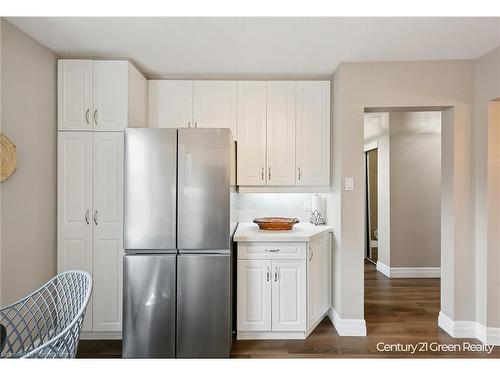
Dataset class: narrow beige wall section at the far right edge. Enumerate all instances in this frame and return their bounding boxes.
[474,47,500,327]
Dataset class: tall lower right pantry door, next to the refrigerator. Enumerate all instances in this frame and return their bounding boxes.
[92,132,124,331]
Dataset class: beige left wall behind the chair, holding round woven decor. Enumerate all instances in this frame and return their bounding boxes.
[0,20,57,305]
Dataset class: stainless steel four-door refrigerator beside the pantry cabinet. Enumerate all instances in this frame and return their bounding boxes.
[123,129,236,358]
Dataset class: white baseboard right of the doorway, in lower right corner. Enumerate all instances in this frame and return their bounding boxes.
[438,311,500,346]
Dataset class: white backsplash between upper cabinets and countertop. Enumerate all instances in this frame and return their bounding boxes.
[238,193,325,222]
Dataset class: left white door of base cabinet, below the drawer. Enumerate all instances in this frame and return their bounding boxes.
[237,260,271,331]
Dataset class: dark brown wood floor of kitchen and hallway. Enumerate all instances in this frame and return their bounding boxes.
[78,262,500,358]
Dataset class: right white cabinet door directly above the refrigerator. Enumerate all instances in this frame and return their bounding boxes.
[193,81,238,140]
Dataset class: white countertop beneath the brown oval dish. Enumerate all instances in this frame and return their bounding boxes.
[234,223,333,242]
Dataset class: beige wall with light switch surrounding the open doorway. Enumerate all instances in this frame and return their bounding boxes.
[329,61,475,320]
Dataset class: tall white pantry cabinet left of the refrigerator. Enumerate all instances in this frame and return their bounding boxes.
[57,60,147,338]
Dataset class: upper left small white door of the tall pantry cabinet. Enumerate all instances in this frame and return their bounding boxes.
[57,60,92,130]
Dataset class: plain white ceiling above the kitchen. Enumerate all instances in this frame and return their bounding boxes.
[8,17,500,78]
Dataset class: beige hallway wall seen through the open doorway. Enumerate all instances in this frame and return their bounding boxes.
[388,112,441,267]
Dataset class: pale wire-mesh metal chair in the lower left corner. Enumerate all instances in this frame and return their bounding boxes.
[0,271,92,358]
